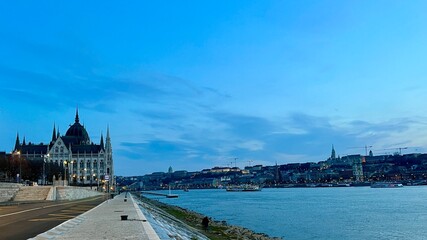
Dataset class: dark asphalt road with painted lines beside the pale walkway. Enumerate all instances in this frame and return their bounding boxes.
[0,196,106,240]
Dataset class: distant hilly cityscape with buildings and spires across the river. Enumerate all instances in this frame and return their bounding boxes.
[117,146,427,190]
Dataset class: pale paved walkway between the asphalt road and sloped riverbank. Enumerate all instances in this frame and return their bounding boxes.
[33,193,159,240]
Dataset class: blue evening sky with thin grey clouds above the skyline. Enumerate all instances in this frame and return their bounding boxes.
[0,0,427,176]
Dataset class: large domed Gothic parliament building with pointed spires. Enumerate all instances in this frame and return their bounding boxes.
[13,109,114,186]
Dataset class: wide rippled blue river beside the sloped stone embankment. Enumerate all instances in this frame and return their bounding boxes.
[150,186,427,240]
